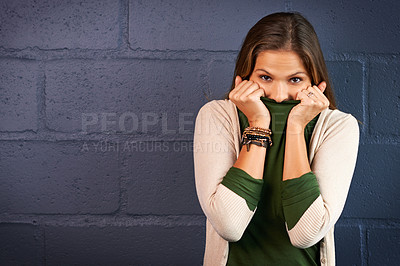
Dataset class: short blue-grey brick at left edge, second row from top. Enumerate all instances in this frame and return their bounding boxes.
[0,59,39,131]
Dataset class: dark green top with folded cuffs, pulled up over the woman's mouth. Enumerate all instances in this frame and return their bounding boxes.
[222,97,320,265]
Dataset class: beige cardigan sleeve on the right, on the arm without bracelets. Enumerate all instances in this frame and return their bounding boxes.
[287,111,359,248]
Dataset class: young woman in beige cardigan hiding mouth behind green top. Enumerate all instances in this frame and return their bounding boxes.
[194,13,359,265]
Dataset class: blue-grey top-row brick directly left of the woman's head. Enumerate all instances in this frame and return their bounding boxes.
[129,0,283,50]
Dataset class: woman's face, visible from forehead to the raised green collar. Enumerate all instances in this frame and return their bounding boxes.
[250,50,311,102]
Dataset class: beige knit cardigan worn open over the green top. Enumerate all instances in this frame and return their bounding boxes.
[193,100,359,265]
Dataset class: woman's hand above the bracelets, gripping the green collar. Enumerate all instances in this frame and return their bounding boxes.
[229,76,271,128]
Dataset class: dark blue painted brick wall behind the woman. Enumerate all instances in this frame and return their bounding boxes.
[0,0,400,265]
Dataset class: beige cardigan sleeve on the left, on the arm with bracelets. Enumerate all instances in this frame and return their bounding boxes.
[193,101,256,242]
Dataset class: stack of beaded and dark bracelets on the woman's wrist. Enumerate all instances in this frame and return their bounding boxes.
[242,127,272,151]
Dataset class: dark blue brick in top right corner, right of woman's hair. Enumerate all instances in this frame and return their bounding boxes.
[290,0,400,53]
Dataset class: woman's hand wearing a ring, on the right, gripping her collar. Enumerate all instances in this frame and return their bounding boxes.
[288,81,329,131]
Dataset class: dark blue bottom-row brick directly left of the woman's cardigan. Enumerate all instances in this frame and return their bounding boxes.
[45,225,205,265]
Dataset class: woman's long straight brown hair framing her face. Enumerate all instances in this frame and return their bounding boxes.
[226,12,336,109]
